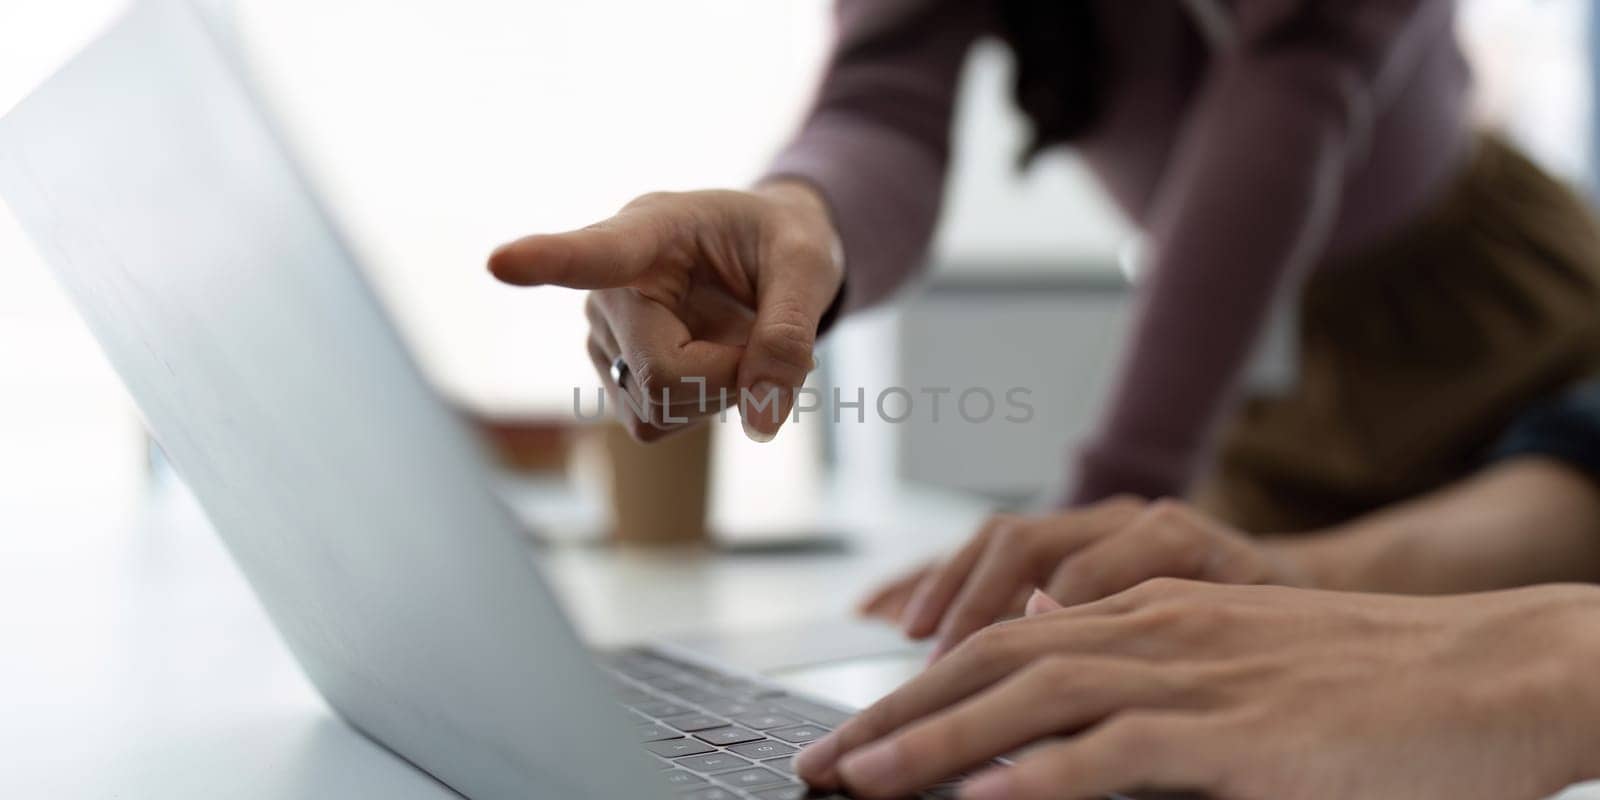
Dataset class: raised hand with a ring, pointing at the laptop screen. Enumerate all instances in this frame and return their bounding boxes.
[490,182,843,442]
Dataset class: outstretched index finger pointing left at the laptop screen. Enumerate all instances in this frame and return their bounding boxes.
[490,210,662,290]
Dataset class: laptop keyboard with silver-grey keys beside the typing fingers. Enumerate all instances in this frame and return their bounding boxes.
[605,648,957,800]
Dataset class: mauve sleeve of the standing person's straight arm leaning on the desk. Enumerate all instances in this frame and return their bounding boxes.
[1069,0,1451,504]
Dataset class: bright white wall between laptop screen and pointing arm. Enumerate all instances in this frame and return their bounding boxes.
[238,0,827,413]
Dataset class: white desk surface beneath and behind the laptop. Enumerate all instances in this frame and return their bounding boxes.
[0,476,1600,800]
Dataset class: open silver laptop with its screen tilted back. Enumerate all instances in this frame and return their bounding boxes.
[0,0,952,800]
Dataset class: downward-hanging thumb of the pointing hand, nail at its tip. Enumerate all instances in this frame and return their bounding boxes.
[739,250,838,442]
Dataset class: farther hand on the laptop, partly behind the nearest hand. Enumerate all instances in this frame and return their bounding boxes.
[859,498,1304,658]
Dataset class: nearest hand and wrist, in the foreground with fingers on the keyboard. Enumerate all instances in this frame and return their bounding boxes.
[806,579,1600,800]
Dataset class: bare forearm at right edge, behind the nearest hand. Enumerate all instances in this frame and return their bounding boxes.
[1267,458,1600,594]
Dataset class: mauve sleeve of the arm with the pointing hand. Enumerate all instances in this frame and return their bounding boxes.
[766,0,990,310]
